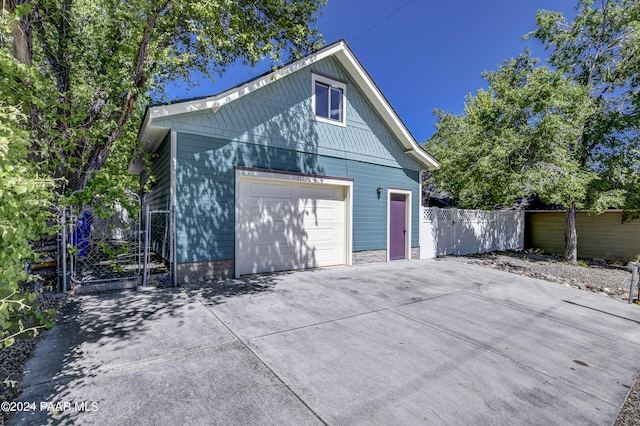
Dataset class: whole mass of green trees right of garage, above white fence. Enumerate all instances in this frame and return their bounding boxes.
[428,0,640,263]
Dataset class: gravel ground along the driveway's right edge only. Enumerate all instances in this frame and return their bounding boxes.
[458,250,640,426]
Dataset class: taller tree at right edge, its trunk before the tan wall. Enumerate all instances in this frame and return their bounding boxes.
[530,0,640,257]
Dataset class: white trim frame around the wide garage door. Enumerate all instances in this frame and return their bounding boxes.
[234,166,353,278]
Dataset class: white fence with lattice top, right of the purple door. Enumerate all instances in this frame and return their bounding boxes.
[420,207,524,259]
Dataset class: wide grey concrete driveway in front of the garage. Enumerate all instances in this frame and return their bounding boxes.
[11,259,640,425]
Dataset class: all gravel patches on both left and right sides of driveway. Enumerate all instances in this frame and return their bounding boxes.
[0,255,640,426]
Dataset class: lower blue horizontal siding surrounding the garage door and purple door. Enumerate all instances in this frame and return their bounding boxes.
[177,133,420,263]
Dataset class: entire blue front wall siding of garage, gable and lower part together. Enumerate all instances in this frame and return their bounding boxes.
[168,58,422,262]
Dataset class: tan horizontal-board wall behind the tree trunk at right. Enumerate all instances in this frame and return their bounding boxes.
[525,211,640,261]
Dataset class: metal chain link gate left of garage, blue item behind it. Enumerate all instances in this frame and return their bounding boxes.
[58,193,177,292]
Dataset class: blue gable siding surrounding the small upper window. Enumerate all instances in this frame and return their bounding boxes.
[154,58,421,170]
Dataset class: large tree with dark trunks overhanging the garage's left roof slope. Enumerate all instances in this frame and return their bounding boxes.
[0,0,324,190]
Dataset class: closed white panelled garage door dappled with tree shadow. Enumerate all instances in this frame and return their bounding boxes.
[236,178,347,275]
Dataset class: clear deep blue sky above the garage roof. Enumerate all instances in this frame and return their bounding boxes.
[170,0,577,142]
